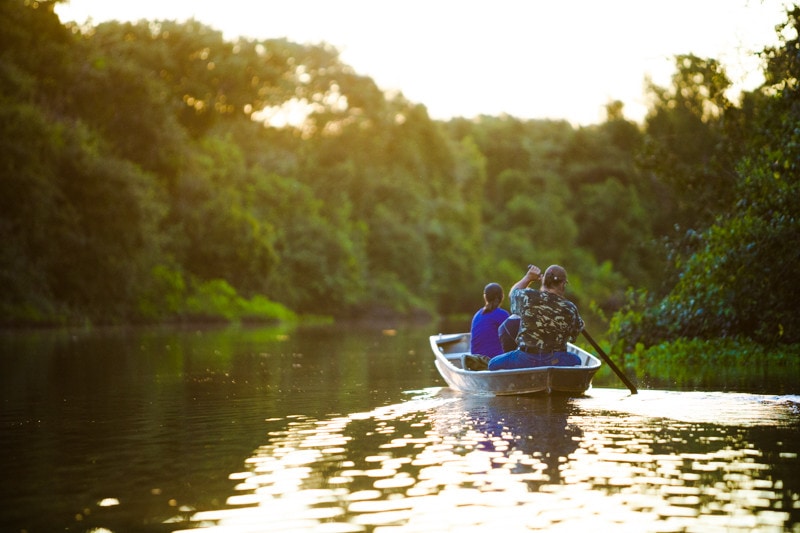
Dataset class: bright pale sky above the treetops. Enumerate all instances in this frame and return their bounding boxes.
[56,0,786,125]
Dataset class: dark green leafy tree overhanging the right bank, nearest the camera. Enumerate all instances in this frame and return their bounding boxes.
[612,8,800,348]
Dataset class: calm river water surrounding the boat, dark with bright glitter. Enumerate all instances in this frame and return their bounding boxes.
[0,325,800,533]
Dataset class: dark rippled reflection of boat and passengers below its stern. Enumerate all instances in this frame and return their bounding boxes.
[433,396,583,485]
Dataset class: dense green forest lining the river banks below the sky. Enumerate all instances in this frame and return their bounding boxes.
[0,0,800,350]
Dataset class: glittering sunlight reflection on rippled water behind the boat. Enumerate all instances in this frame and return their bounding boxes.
[177,388,800,533]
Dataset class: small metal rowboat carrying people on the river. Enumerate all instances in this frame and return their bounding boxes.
[430,333,602,396]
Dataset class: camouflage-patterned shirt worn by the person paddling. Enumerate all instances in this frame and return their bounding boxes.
[511,289,583,353]
